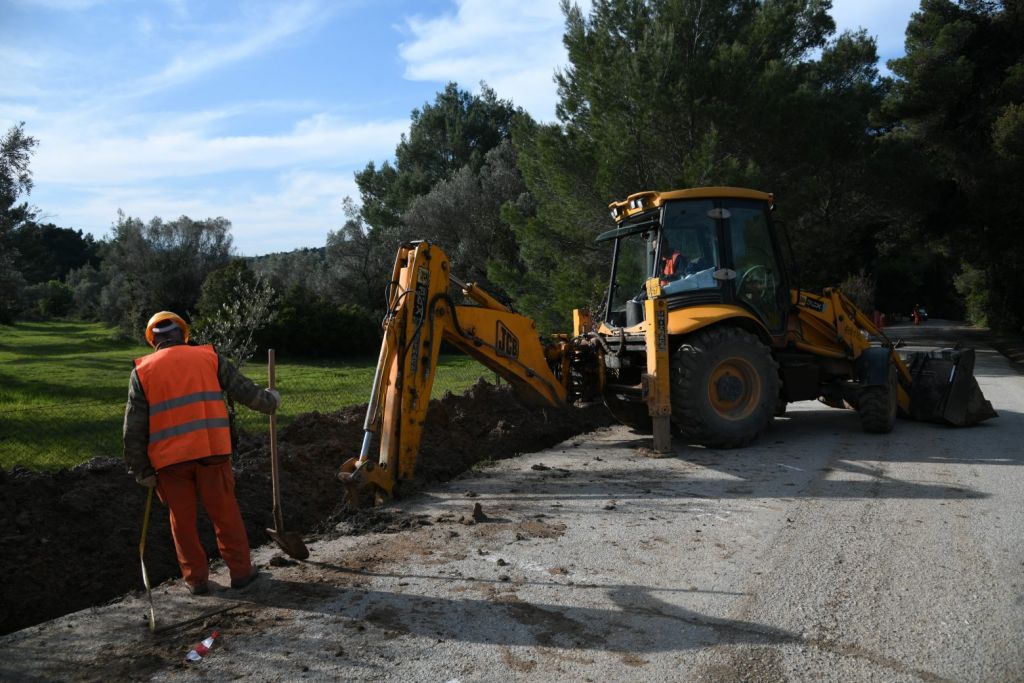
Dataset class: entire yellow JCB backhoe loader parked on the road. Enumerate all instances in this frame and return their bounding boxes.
[339,187,995,504]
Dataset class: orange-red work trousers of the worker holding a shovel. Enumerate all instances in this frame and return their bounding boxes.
[157,457,252,586]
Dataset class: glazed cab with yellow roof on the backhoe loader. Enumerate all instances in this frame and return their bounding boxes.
[598,187,790,334]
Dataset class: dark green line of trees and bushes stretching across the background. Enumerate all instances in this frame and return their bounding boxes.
[0,0,1024,353]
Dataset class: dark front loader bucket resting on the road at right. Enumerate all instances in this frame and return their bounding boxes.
[907,348,998,427]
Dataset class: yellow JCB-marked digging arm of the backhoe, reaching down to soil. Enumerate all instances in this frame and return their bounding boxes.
[338,242,570,505]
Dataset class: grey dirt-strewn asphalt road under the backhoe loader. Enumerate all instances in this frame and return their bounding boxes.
[0,321,1024,683]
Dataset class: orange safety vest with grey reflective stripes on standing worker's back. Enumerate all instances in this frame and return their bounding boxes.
[135,345,231,470]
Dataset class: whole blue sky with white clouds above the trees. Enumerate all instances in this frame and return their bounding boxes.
[0,0,919,255]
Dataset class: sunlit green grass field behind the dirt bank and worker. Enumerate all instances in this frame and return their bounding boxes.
[0,322,494,470]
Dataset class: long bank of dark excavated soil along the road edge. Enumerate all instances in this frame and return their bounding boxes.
[0,381,611,634]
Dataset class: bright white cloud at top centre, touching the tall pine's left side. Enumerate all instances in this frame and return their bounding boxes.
[399,0,590,121]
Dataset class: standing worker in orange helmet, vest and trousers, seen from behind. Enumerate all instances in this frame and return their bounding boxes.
[124,310,281,595]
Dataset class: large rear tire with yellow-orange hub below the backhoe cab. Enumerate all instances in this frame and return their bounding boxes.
[672,327,779,449]
